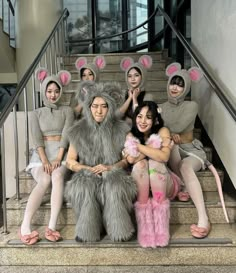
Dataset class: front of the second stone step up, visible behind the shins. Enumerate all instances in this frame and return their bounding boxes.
[7,194,236,225]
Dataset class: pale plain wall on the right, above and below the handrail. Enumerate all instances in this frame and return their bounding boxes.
[191,0,236,187]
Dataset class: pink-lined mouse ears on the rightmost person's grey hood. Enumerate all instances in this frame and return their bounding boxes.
[166,63,203,82]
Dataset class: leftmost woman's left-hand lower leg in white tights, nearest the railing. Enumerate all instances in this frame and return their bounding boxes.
[21,167,51,235]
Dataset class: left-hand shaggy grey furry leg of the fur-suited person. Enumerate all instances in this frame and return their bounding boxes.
[66,171,102,242]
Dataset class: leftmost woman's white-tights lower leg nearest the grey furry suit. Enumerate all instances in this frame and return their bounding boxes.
[48,166,67,230]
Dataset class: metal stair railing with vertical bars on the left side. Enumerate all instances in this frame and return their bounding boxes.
[0,9,69,233]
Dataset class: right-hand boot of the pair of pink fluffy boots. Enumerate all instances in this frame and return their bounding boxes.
[152,199,170,247]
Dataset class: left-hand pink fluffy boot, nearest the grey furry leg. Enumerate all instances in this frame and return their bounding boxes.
[135,199,156,248]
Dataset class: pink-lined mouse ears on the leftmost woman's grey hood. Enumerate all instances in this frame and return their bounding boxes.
[35,67,71,86]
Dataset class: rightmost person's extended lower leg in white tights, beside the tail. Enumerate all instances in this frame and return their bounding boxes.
[180,156,208,228]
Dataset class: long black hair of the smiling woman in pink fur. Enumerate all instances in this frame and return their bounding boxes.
[131,101,164,144]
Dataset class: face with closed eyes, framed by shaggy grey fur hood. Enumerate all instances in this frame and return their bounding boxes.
[90,97,108,123]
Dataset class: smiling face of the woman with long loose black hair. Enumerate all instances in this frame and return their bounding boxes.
[136,106,153,134]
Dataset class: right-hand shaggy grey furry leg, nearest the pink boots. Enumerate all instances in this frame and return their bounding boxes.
[103,171,136,241]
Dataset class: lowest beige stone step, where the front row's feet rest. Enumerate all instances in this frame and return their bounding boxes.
[0,223,236,264]
